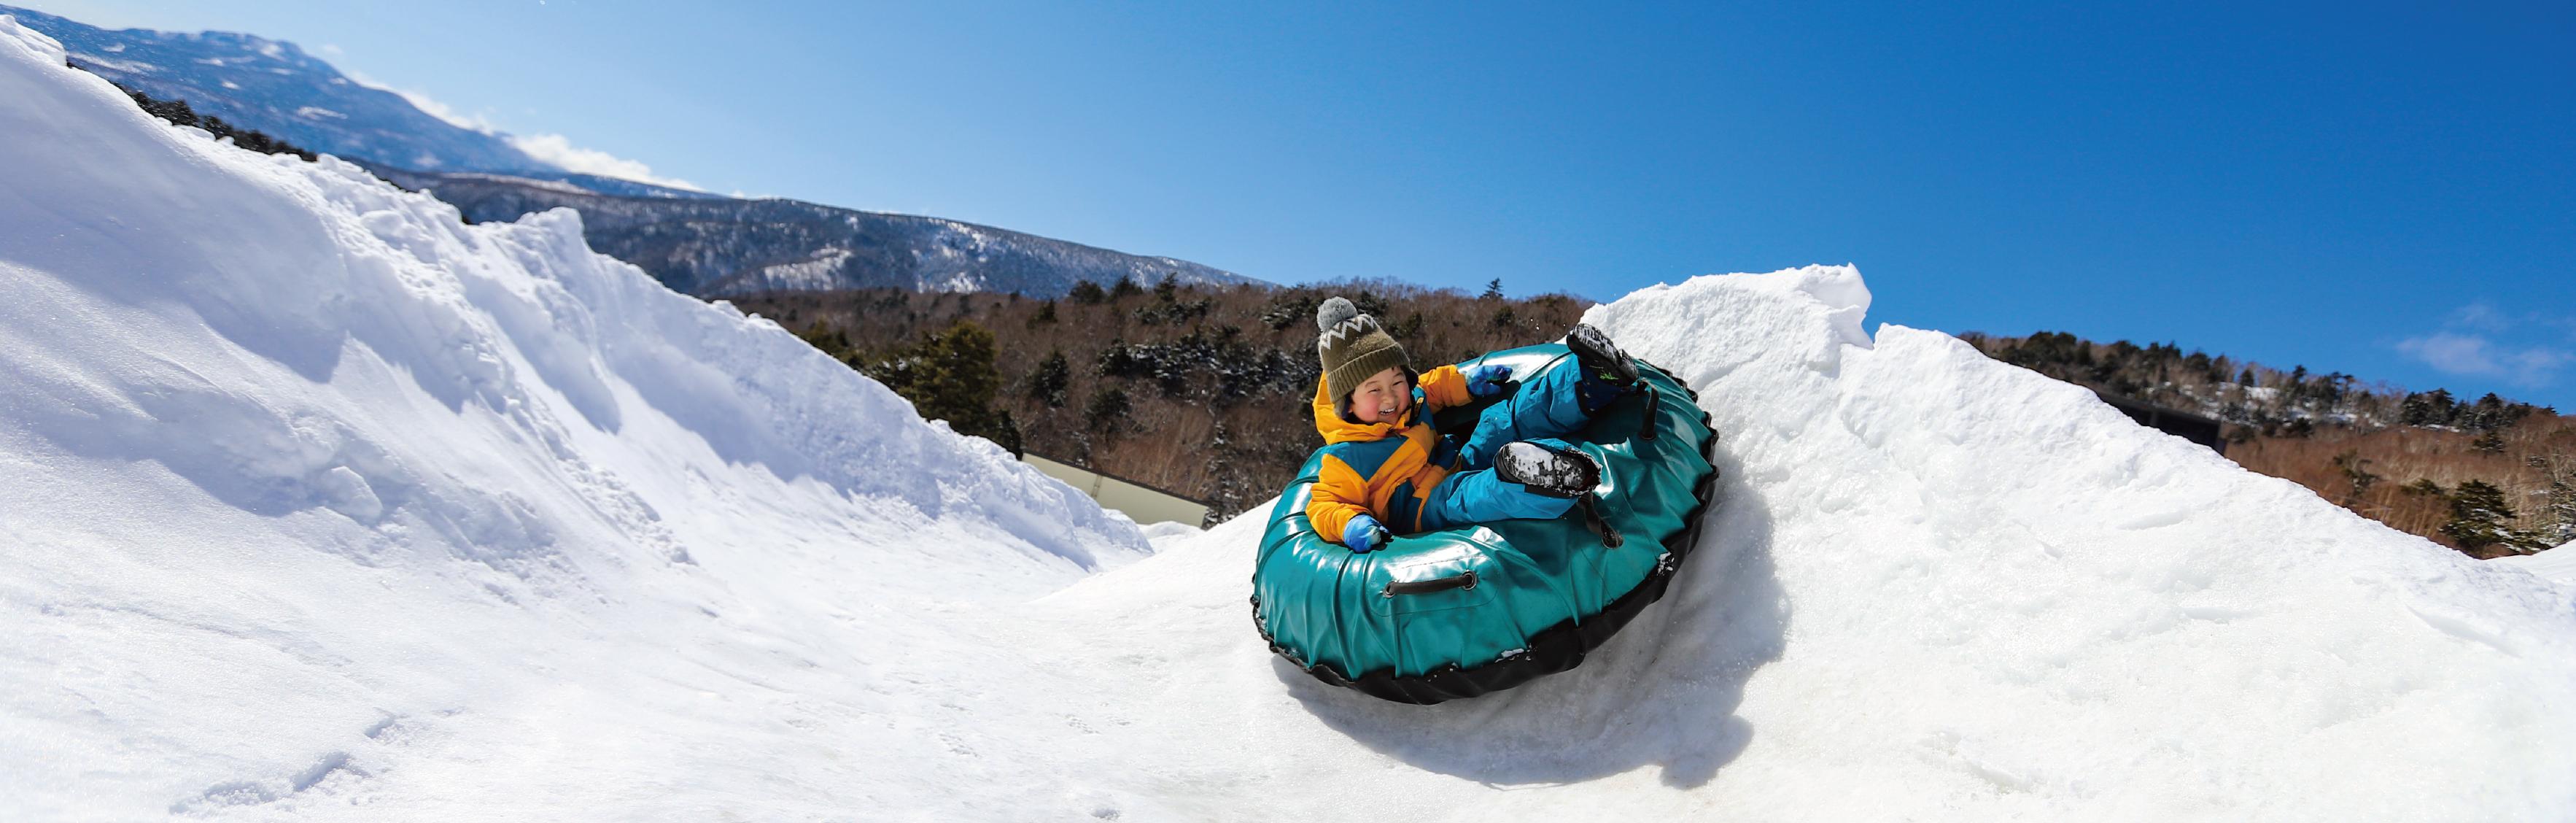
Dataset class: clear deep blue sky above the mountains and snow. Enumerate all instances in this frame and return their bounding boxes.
[18,0,2576,410]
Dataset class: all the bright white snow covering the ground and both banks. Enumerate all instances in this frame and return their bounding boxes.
[0,18,2576,820]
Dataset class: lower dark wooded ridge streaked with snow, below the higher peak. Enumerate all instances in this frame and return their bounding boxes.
[376,168,1254,297]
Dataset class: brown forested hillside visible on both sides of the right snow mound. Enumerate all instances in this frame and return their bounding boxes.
[734,281,2576,557]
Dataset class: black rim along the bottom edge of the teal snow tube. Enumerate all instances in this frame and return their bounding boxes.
[1252,366,1720,704]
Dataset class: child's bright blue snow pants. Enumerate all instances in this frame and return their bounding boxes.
[1422,358,1597,531]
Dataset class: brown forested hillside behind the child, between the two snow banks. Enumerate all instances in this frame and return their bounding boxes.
[734,281,1584,519]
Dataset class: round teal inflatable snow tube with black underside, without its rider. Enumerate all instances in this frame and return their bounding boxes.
[1252,343,1718,704]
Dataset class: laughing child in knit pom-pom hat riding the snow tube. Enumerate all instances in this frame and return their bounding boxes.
[1306,297,1641,552]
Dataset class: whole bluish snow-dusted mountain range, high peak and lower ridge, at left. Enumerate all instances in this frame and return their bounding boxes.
[0,5,1252,297]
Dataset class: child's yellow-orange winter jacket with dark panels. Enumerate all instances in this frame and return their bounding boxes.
[1306,366,1473,542]
